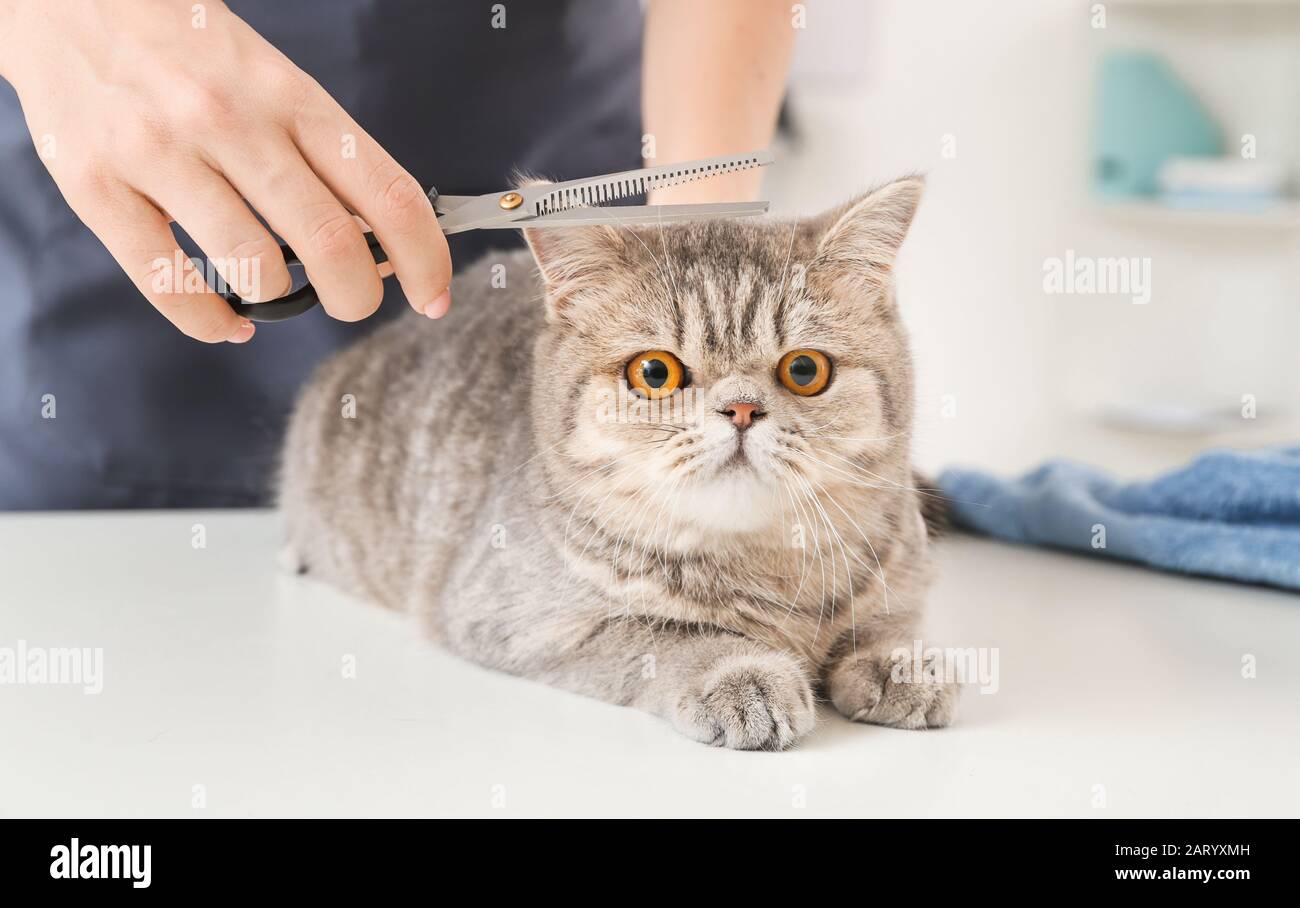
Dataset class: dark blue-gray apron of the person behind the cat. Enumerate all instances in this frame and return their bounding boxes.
[0,0,641,510]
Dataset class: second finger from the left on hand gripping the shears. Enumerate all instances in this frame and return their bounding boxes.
[146,161,293,303]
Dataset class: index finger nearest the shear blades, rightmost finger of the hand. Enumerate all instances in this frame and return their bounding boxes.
[291,94,451,317]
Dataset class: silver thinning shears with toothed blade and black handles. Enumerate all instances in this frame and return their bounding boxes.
[217,151,772,321]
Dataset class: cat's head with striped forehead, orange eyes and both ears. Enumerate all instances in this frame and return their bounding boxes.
[525,178,922,536]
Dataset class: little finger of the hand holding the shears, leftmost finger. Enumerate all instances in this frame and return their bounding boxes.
[74,185,255,343]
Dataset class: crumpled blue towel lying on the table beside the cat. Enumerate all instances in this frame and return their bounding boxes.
[939,447,1300,589]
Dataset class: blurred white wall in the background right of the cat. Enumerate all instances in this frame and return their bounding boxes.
[768,0,1300,472]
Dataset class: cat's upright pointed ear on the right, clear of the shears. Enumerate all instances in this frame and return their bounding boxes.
[811,176,924,284]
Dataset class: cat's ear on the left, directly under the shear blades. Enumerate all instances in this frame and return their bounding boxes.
[524,225,628,320]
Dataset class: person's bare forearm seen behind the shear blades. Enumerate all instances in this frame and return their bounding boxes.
[641,0,794,203]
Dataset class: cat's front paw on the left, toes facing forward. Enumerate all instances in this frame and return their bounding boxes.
[672,650,816,751]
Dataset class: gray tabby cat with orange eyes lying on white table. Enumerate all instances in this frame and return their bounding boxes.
[281,178,957,748]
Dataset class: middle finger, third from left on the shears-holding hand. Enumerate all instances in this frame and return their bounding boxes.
[217,138,384,321]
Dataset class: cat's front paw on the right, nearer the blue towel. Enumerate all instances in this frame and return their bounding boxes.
[827,656,958,728]
